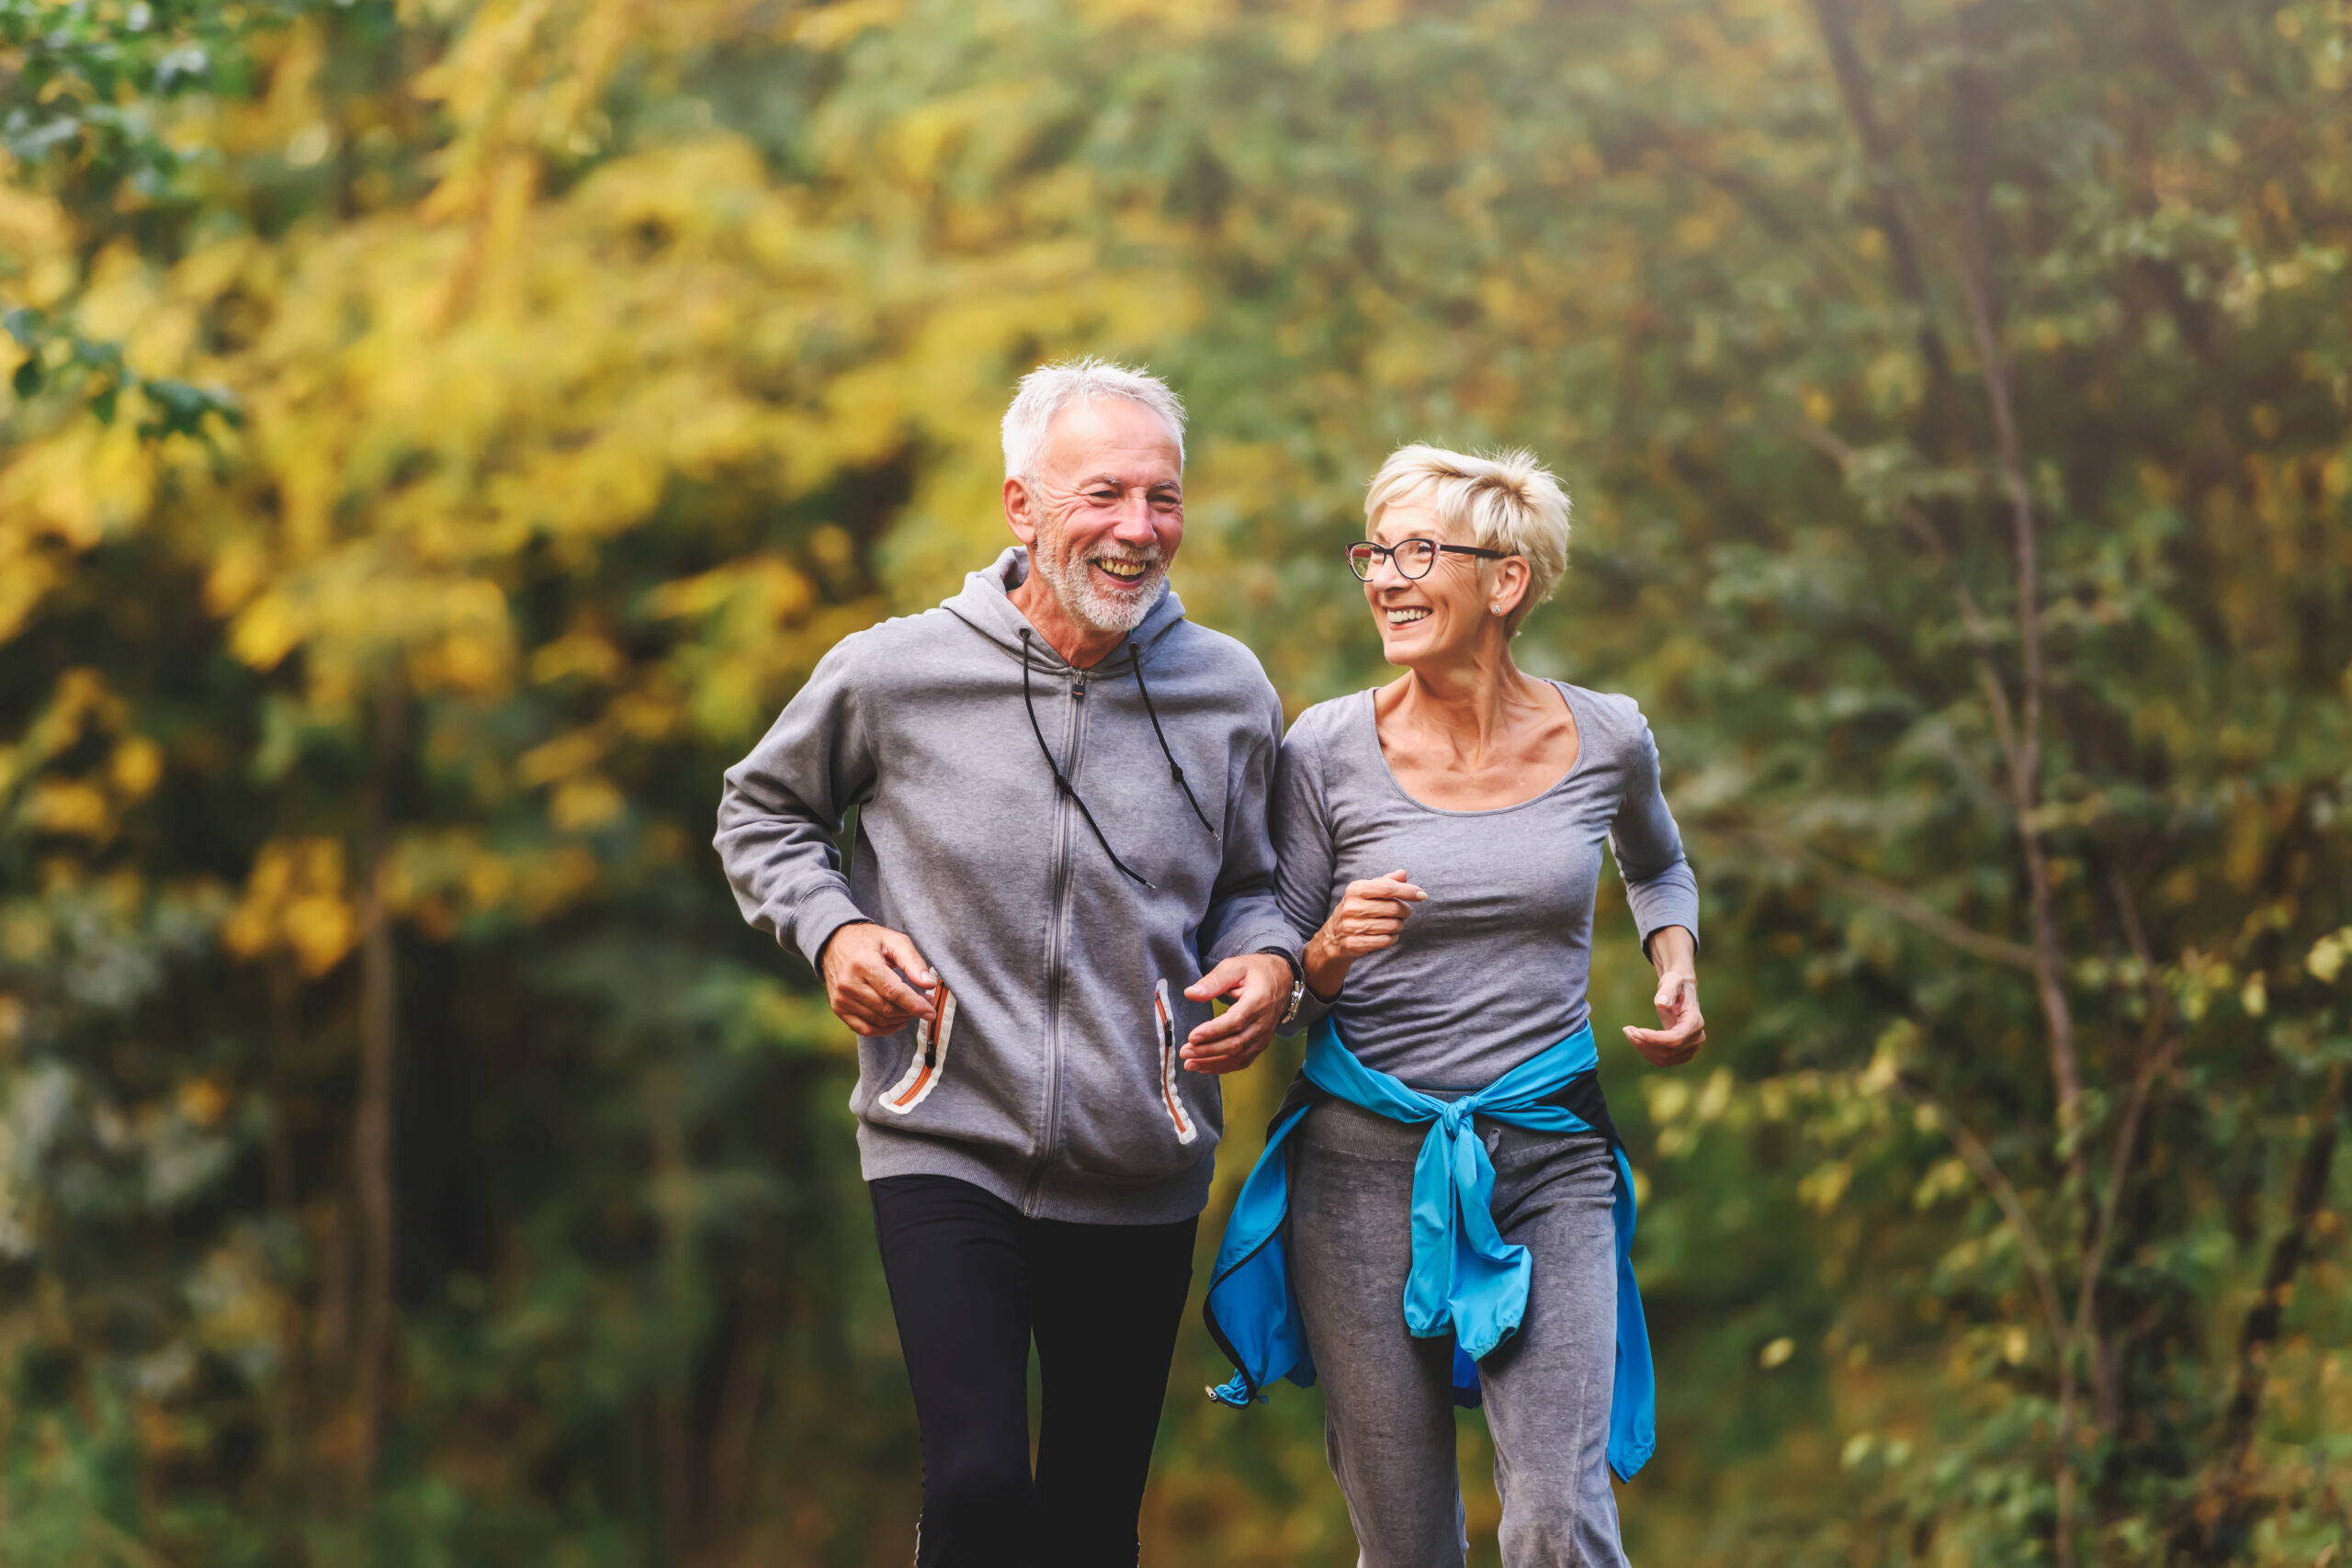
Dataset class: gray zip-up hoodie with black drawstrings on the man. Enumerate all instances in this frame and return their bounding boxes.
[715,547,1298,1224]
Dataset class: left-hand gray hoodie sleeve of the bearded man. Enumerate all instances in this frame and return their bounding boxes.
[713,637,875,966]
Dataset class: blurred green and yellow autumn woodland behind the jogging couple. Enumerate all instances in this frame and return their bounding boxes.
[0,0,2352,1568]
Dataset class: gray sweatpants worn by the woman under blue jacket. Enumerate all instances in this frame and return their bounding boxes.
[1289,1102,1625,1568]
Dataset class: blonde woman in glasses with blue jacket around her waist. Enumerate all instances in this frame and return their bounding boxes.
[1209,446,1705,1568]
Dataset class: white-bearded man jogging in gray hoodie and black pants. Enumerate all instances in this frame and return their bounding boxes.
[718,360,1301,1568]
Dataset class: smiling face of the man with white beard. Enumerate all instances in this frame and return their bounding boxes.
[1009,398,1183,632]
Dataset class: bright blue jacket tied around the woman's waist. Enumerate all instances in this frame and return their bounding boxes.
[1204,1018,1658,1481]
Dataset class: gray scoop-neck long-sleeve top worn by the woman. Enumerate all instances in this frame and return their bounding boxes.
[1272,682,1698,1090]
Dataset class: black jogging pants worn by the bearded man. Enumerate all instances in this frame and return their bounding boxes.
[868,1176,1200,1568]
